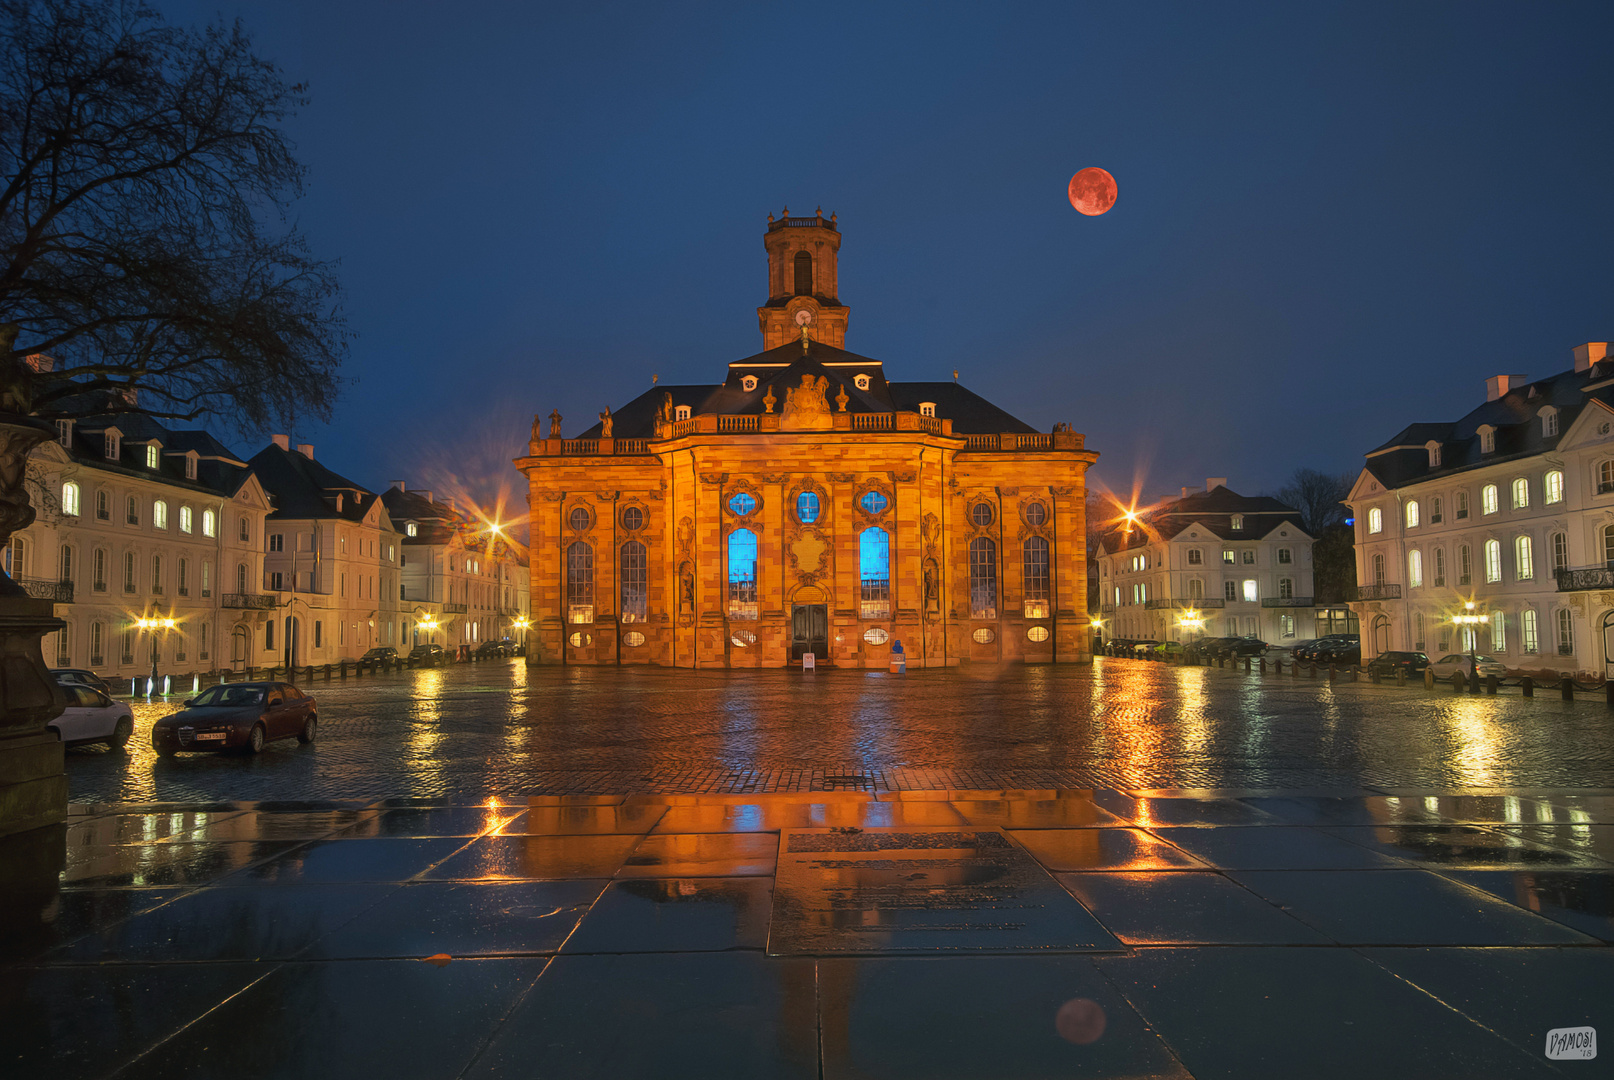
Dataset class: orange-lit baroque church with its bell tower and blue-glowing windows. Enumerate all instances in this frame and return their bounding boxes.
[515,215,1098,668]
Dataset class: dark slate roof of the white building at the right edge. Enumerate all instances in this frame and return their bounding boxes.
[1367,360,1614,491]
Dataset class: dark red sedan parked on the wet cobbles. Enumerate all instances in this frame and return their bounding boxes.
[152,683,320,757]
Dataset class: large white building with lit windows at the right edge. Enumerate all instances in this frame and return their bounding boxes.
[1348,342,1614,673]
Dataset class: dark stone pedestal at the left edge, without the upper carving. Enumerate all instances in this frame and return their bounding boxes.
[0,596,68,836]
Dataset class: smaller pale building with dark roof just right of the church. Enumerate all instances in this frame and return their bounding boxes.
[1098,476,1329,644]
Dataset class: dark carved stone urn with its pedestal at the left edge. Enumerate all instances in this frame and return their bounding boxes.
[0,413,68,836]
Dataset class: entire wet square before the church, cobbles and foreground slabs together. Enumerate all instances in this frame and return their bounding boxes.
[15,660,1614,1080]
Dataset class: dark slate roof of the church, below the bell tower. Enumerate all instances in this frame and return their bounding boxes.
[576,341,1036,439]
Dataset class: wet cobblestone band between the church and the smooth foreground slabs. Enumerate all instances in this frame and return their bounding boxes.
[56,659,1614,802]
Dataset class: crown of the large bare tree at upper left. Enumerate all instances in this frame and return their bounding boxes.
[0,0,349,429]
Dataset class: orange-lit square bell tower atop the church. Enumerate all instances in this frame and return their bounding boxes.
[757,208,849,349]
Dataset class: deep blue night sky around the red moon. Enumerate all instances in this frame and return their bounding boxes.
[160,0,1614,513]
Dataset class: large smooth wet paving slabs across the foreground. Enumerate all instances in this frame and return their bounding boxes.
[0,788,1614,1080]
